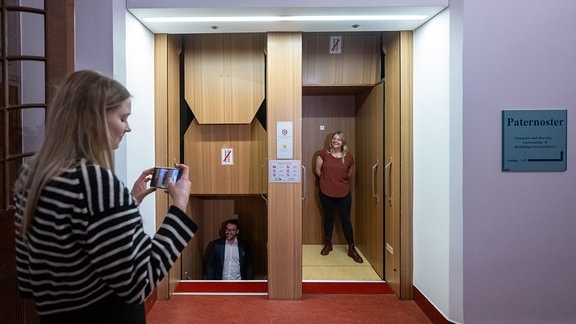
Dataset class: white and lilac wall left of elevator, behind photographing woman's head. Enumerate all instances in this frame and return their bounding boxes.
[74,0,156,234]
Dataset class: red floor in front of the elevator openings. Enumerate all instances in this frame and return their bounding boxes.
[147,294,432,324]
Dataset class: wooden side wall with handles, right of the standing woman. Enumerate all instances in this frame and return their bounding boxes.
[355,84,384,278]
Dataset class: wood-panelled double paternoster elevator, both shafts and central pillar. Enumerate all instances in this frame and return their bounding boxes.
[155,32,412,300]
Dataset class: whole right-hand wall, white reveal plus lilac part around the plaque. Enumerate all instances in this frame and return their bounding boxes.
[414,0,576,324]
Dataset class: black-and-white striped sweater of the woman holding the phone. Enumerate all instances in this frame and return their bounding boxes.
[14,161,197,315]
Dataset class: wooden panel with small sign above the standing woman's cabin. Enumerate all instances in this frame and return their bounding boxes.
[302,32,380,86]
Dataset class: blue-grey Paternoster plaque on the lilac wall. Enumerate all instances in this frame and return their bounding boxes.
[502,109,568,171]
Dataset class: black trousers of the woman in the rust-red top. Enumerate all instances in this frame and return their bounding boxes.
[320,191,354,245]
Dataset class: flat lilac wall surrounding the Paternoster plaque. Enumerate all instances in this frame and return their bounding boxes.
[462,0,576,324]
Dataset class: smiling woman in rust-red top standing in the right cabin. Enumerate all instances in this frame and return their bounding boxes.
[316,131,363,263]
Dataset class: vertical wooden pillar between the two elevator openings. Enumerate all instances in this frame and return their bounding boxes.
[266,33,302,300]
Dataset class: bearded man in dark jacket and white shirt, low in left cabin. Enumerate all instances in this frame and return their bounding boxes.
[206,219,252,280]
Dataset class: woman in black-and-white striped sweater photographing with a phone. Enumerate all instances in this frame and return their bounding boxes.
[14,71,197,324]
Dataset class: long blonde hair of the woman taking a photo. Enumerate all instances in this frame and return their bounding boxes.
[15,70,131,235]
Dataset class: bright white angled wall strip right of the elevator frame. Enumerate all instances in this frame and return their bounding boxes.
[413,10,463,322]
